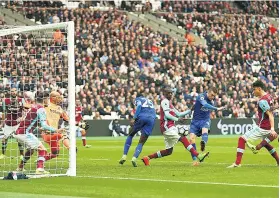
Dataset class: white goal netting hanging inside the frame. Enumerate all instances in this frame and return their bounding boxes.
[0,22,75,177]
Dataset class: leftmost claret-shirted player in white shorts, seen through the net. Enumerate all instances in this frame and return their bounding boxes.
[0,88,25,159]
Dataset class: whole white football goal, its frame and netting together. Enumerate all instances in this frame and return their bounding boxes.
[0,22,76,177]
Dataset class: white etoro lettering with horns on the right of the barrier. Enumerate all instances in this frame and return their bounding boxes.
[217,119,256,135]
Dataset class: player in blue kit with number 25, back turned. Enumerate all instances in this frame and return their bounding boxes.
[119,95,156,167]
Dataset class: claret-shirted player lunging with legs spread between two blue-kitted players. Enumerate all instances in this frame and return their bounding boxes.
[142,88,209,166]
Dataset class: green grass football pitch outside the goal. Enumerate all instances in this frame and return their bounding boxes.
[0,136,279,198]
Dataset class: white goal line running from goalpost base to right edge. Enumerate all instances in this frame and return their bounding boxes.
[77,176,279,188]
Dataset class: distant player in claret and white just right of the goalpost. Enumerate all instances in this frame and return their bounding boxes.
[75,99,91,148]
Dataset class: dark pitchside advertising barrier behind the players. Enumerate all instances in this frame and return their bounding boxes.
[87,118,279,137]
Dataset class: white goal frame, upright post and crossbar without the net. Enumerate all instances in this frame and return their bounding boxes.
[0,21,76,176]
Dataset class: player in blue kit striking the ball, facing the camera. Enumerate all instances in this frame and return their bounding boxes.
[190,87,224,166]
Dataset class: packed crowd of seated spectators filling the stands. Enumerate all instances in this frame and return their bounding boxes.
[0,1,279,119]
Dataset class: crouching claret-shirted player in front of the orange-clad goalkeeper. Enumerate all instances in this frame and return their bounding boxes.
[14,93,63,174]
